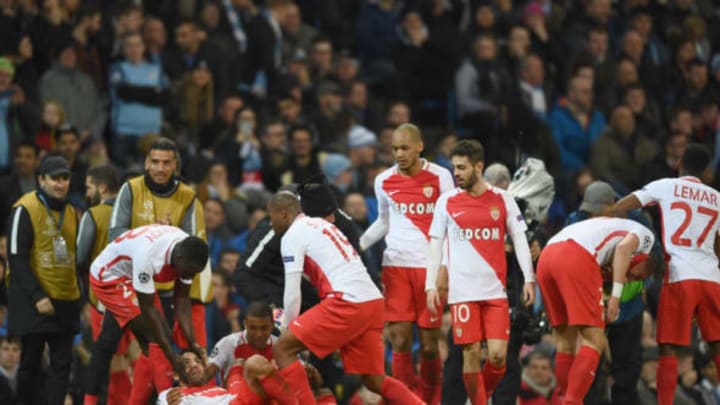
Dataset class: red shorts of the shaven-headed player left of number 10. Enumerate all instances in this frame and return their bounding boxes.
[382,266,445,329]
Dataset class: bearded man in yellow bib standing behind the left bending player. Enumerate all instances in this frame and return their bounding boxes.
[108,138,212,402]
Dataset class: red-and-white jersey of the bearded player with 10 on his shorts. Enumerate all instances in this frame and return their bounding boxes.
[430,187,527,304]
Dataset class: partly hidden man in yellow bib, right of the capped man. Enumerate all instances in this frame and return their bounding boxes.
[76,165,132,405]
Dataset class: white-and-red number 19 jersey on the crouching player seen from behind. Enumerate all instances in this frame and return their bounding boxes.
[280,214,382,303]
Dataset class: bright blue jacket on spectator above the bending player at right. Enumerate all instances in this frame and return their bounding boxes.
[548,105,605,171]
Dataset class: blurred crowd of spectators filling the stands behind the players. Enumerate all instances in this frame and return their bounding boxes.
[0,0,720,404]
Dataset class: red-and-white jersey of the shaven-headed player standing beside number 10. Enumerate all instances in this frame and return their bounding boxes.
[375,161,454,269]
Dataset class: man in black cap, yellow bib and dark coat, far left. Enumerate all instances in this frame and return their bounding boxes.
[8,155,80,404]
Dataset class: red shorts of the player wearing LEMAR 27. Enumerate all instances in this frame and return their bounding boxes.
[657,280,720,346]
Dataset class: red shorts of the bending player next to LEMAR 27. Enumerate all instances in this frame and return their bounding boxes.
[537,240,605,328]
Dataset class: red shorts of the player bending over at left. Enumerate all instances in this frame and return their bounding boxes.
[90,277,140,328]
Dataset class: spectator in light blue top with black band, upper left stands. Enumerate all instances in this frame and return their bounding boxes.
[110,32,169,165]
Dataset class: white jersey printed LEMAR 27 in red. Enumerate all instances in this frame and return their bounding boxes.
[633,176,720,283]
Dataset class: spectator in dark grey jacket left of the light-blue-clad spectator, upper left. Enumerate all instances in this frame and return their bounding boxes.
[40,41,107,140]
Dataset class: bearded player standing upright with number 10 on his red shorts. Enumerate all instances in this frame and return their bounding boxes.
[425,140,535,405]
